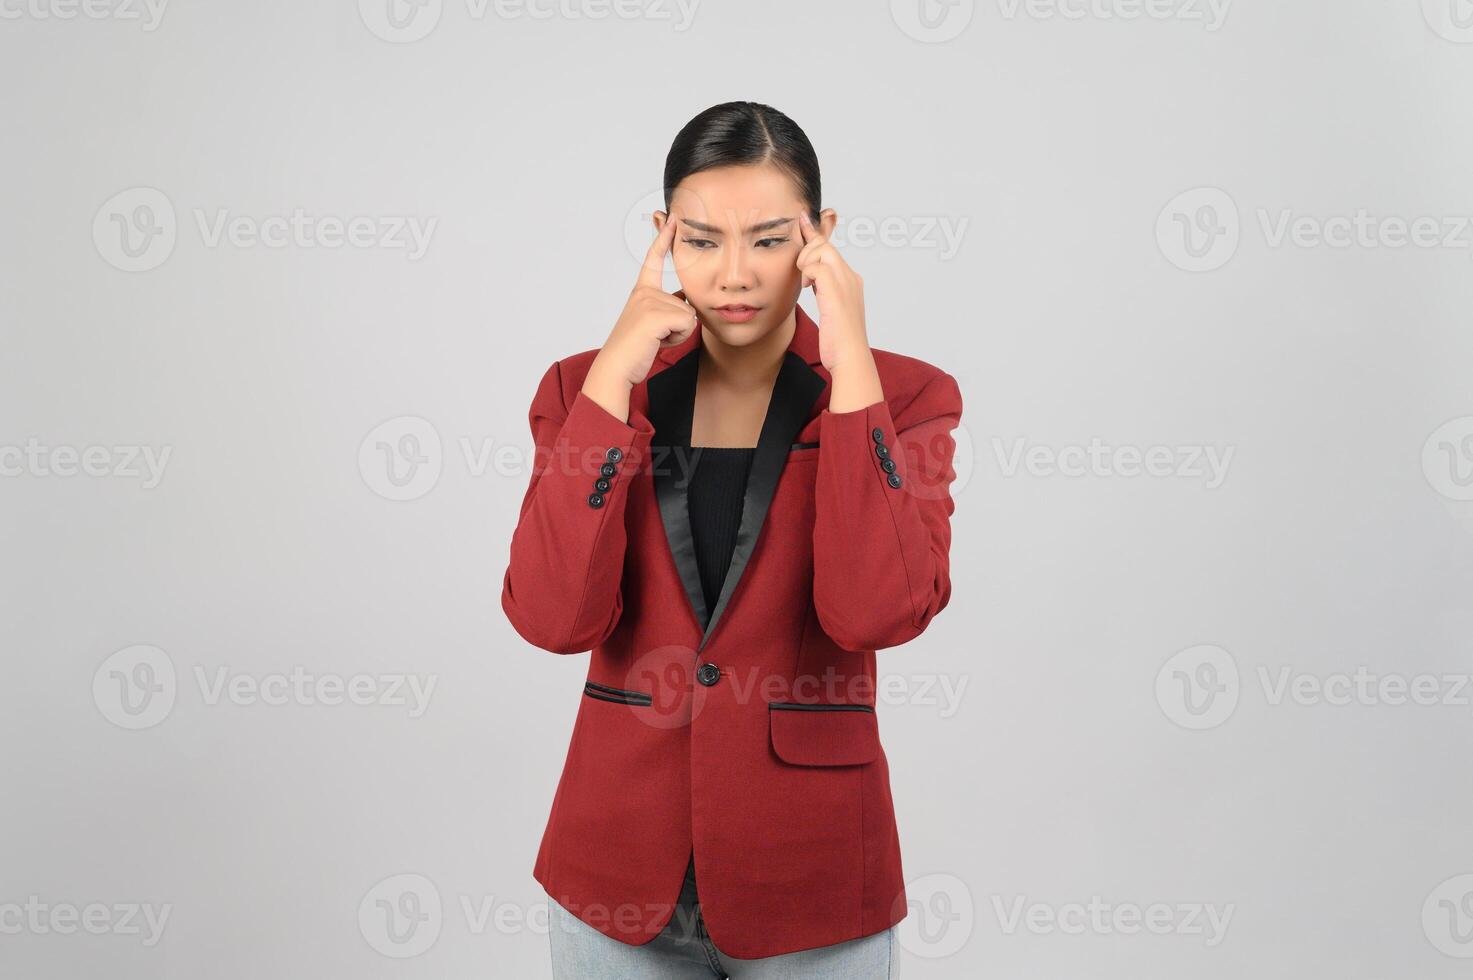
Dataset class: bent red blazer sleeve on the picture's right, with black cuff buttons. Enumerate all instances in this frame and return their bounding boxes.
[813,371,962,651]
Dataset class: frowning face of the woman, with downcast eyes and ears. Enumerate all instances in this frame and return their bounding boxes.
[654,164,835,346]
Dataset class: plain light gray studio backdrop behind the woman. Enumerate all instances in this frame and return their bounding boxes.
[0,0,1473,980]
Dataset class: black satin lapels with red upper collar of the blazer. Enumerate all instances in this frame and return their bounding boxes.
[645,307,828,650]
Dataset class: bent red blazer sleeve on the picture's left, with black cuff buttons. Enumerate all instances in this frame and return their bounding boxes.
[501,363,654,653]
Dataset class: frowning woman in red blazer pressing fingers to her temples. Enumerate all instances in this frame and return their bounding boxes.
[502,102,962,979]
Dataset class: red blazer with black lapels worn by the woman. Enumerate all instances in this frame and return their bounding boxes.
[501,308,962,959]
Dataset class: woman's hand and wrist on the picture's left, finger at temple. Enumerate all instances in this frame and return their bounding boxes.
[583,212,700,419]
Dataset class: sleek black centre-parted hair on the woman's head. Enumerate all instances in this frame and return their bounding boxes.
[664,102,822,224]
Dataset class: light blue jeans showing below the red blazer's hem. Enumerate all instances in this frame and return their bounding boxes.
[548,859,900,980]
